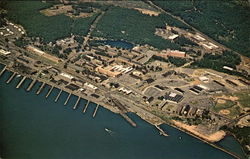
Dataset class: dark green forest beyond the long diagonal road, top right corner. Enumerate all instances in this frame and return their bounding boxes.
[154,0,250,57]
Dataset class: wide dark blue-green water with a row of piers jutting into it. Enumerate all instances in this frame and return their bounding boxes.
[0,67,246,159]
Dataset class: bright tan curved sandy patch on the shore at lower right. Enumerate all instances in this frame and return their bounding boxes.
[172,120,226,142]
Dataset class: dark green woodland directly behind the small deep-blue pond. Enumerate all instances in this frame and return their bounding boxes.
[93,7,192,50]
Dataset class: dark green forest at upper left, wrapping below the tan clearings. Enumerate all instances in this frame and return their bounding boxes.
[4,1,96,43]
